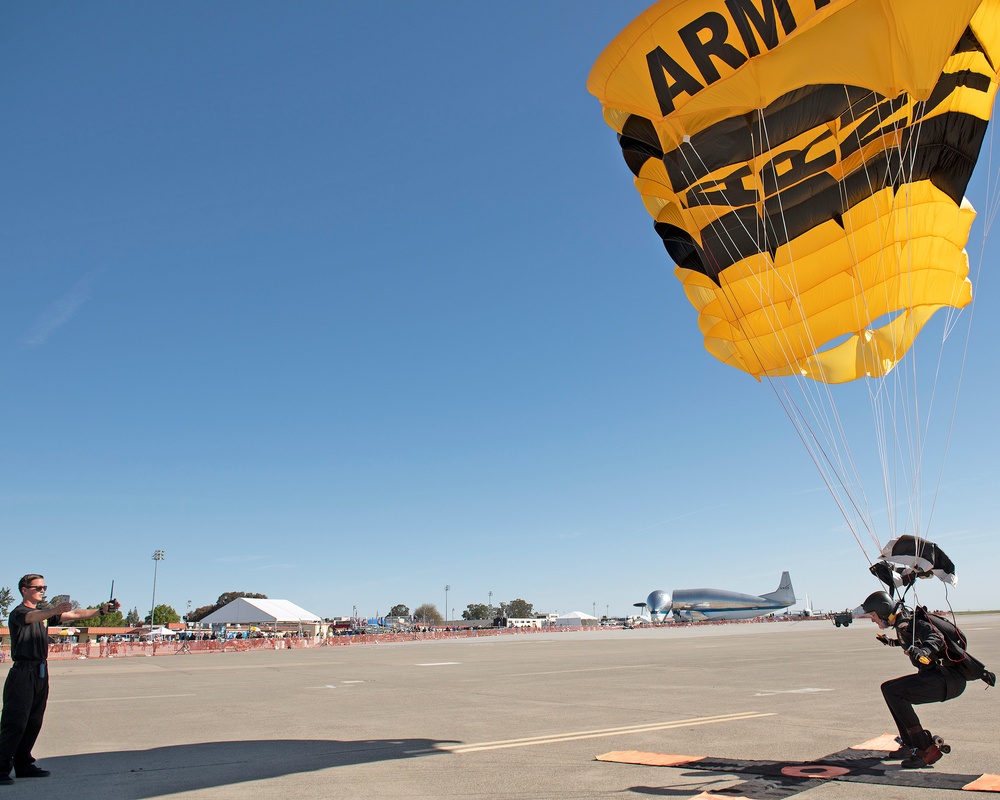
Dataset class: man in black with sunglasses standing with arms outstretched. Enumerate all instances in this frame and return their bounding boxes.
[0,575,119,785]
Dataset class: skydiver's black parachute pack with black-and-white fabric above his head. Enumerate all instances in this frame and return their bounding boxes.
[870,535,996,686]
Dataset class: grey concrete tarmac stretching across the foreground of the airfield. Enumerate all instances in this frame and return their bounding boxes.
[0,615,1000,800]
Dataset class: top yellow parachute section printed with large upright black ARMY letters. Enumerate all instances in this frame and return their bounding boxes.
[587,0,988,147]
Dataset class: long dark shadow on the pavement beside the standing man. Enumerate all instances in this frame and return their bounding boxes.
[22,739,456,800]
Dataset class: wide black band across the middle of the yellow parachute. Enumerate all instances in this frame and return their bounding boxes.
[618,31,990,284]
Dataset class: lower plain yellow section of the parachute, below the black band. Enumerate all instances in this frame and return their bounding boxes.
[675,182,975,383]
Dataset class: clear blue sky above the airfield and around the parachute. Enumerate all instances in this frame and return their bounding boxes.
[0,0,1000,615]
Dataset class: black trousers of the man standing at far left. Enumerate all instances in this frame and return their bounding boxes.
[0,662,49,776]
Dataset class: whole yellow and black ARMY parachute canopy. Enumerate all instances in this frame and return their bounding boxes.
[587,0,1000,383]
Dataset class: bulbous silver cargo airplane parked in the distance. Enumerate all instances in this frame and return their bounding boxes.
[635,572,795,622]
